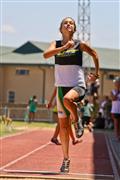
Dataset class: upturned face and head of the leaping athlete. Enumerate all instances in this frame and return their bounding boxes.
[60,18,76,34]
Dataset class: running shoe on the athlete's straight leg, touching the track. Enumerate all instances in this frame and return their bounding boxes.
[60,159,70,173]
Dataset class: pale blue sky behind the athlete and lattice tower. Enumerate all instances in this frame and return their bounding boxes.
[0,0,120,48]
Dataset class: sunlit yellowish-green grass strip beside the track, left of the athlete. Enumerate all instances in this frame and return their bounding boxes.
[0,121,55,137]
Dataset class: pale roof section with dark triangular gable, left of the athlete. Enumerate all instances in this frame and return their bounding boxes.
[0,41,54,65]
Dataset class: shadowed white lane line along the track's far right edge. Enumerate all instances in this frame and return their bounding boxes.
[105,135,120,180]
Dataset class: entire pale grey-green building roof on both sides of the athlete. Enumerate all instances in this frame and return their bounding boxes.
[0,41,120,70]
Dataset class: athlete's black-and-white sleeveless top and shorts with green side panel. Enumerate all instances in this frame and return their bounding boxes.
[55,40,86,118]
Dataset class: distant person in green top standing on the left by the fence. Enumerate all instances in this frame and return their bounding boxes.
[28,95,37,123]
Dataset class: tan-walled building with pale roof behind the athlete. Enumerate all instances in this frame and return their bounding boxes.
[0,41,120,104]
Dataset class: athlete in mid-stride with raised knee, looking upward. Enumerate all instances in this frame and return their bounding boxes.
[43,17,99,173]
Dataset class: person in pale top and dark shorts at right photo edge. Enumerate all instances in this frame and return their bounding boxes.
[111,77,120,141]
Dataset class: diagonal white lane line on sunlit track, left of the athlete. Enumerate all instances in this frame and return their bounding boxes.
[0,141,51,171]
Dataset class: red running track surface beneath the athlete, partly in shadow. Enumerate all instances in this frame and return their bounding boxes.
[0,129,113,180]
